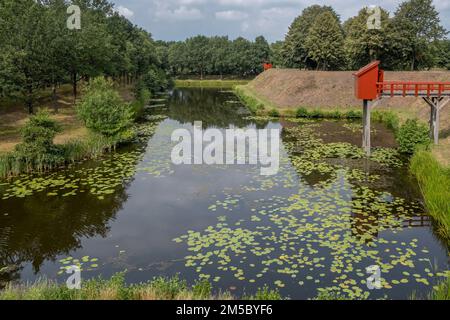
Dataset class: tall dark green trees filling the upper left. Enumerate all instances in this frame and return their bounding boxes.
[0,0,171,113]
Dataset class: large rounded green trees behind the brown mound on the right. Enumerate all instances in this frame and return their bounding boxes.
[280,0,450,70]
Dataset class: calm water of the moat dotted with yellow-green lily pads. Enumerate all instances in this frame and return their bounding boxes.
[0,89,448,299]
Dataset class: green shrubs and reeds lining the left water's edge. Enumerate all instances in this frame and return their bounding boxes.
[0,77,151,178]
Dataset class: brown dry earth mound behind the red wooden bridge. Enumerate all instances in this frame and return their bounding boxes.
[248,69,450,135]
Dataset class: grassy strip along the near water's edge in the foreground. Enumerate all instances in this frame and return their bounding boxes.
[0,273,281,300]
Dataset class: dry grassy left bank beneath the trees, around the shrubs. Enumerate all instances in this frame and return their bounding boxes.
[0,82,145,178]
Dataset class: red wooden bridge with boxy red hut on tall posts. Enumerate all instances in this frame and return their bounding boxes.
[354,61,450,155]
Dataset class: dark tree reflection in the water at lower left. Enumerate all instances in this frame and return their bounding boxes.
[0,181,127,284]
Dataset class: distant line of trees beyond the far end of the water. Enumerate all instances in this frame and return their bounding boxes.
[158,36,271,78]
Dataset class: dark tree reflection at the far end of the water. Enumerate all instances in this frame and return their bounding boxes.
[168,89,252,129]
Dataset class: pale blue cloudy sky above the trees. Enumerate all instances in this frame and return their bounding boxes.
[112,0,450,41]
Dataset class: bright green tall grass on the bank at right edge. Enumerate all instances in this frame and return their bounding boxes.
[410,149,450,242]
